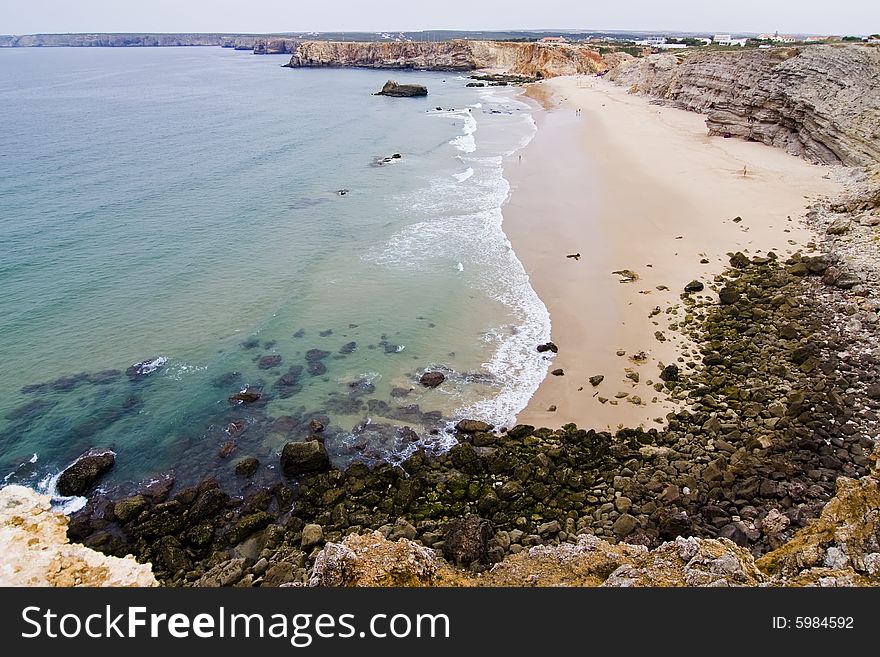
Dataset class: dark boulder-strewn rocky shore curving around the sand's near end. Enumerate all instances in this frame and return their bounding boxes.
[68,229,880,586]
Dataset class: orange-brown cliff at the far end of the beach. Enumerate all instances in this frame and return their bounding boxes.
[289,39,607,77]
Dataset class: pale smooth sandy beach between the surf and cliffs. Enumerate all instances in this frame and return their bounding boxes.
[504,76,839,428]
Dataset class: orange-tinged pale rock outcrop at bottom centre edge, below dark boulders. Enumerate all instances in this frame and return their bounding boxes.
[309,532,443,587]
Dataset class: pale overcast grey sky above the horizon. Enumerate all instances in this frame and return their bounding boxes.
[0,0,880,35]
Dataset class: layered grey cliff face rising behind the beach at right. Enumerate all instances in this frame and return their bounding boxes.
[608,45,880,166]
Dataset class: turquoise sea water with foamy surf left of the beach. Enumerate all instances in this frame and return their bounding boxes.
[0,48,549,498]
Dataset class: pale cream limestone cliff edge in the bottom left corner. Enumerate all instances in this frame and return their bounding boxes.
[0,486,159,586]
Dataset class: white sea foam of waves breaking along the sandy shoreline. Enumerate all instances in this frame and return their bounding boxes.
[365,84,550,428]
